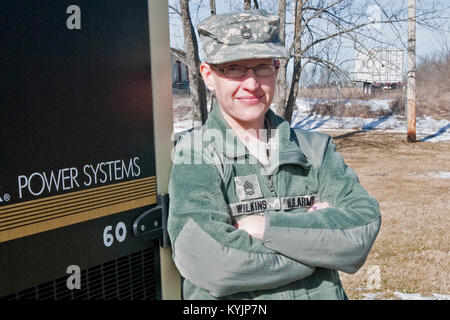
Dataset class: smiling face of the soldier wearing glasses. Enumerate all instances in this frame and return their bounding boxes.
[200,59,278,130]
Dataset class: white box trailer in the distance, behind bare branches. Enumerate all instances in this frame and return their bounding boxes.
[354,49,403,94]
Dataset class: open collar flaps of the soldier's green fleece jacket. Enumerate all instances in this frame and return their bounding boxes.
[205,103,312,174]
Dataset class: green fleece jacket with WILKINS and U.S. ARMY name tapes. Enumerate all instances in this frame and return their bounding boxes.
[168,106,381,299]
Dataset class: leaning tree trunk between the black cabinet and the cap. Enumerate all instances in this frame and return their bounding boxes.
[180,0,208,126]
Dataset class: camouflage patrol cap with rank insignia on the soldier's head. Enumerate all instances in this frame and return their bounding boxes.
[198,10,287,64]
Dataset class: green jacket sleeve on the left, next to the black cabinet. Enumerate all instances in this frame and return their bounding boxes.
[168,131,314,297]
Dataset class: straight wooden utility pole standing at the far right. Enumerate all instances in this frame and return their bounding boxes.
[406,0,416,142]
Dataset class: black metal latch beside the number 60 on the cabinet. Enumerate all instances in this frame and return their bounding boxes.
[133,193,170,248]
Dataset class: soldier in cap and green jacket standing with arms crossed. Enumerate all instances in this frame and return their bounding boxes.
[168,10,381,299]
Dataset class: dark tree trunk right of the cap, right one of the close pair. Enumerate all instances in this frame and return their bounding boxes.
[284,0,303,123]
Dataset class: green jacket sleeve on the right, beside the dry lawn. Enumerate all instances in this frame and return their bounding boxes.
[263,136,381,273]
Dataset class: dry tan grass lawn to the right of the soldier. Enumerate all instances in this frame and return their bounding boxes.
[329,131,450,299]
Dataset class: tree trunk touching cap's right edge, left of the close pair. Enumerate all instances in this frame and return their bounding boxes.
[274,0,289,116]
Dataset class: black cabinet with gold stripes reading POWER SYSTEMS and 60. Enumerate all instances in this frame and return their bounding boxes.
[0,0,180,299]
